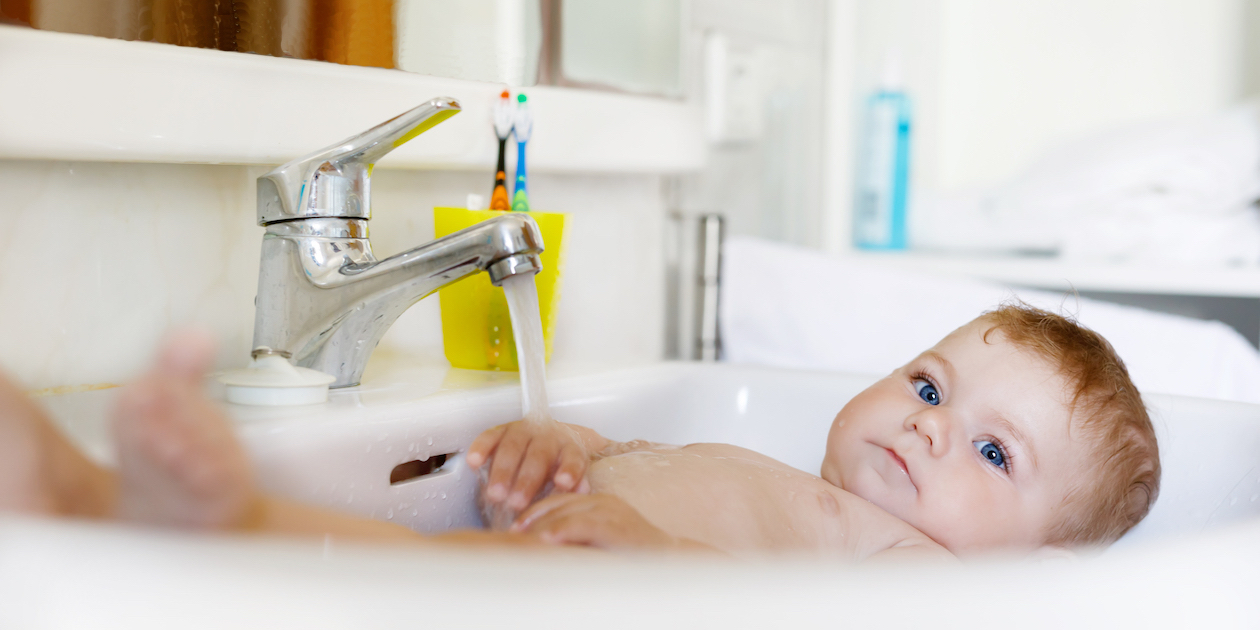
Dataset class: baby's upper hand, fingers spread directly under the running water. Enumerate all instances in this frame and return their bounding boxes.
[467,420,590,510]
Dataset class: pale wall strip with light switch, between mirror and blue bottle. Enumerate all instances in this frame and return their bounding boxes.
[677,0,827,247]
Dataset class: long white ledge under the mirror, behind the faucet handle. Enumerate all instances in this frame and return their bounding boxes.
[0,26,704,173]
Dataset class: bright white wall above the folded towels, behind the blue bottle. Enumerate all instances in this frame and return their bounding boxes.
[833,0,1254,190]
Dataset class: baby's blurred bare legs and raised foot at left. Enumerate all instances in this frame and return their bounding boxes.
[0,334,538,546]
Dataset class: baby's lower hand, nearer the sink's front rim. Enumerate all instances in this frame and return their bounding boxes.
[510,494,702,551]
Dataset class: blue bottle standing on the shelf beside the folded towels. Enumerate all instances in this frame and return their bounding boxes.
[853,59,911,249]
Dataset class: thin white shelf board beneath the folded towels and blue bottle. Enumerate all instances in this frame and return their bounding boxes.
[848,252,1260,297]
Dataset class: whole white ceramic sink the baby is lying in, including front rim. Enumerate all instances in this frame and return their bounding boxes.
[14,363,1260,627]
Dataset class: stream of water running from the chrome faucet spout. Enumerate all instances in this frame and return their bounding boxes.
[503,273,551,422]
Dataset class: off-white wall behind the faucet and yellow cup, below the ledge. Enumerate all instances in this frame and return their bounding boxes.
[0,161,664,389]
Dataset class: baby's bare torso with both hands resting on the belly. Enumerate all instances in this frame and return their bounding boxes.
[469,421,951,562]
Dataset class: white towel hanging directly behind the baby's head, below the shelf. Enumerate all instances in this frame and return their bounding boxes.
[719,237,1260,403]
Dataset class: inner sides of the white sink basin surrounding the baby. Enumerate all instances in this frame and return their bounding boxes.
[34,363,1260,547]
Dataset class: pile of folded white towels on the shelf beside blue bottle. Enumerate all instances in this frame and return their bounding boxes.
[910,102,1260,265]
